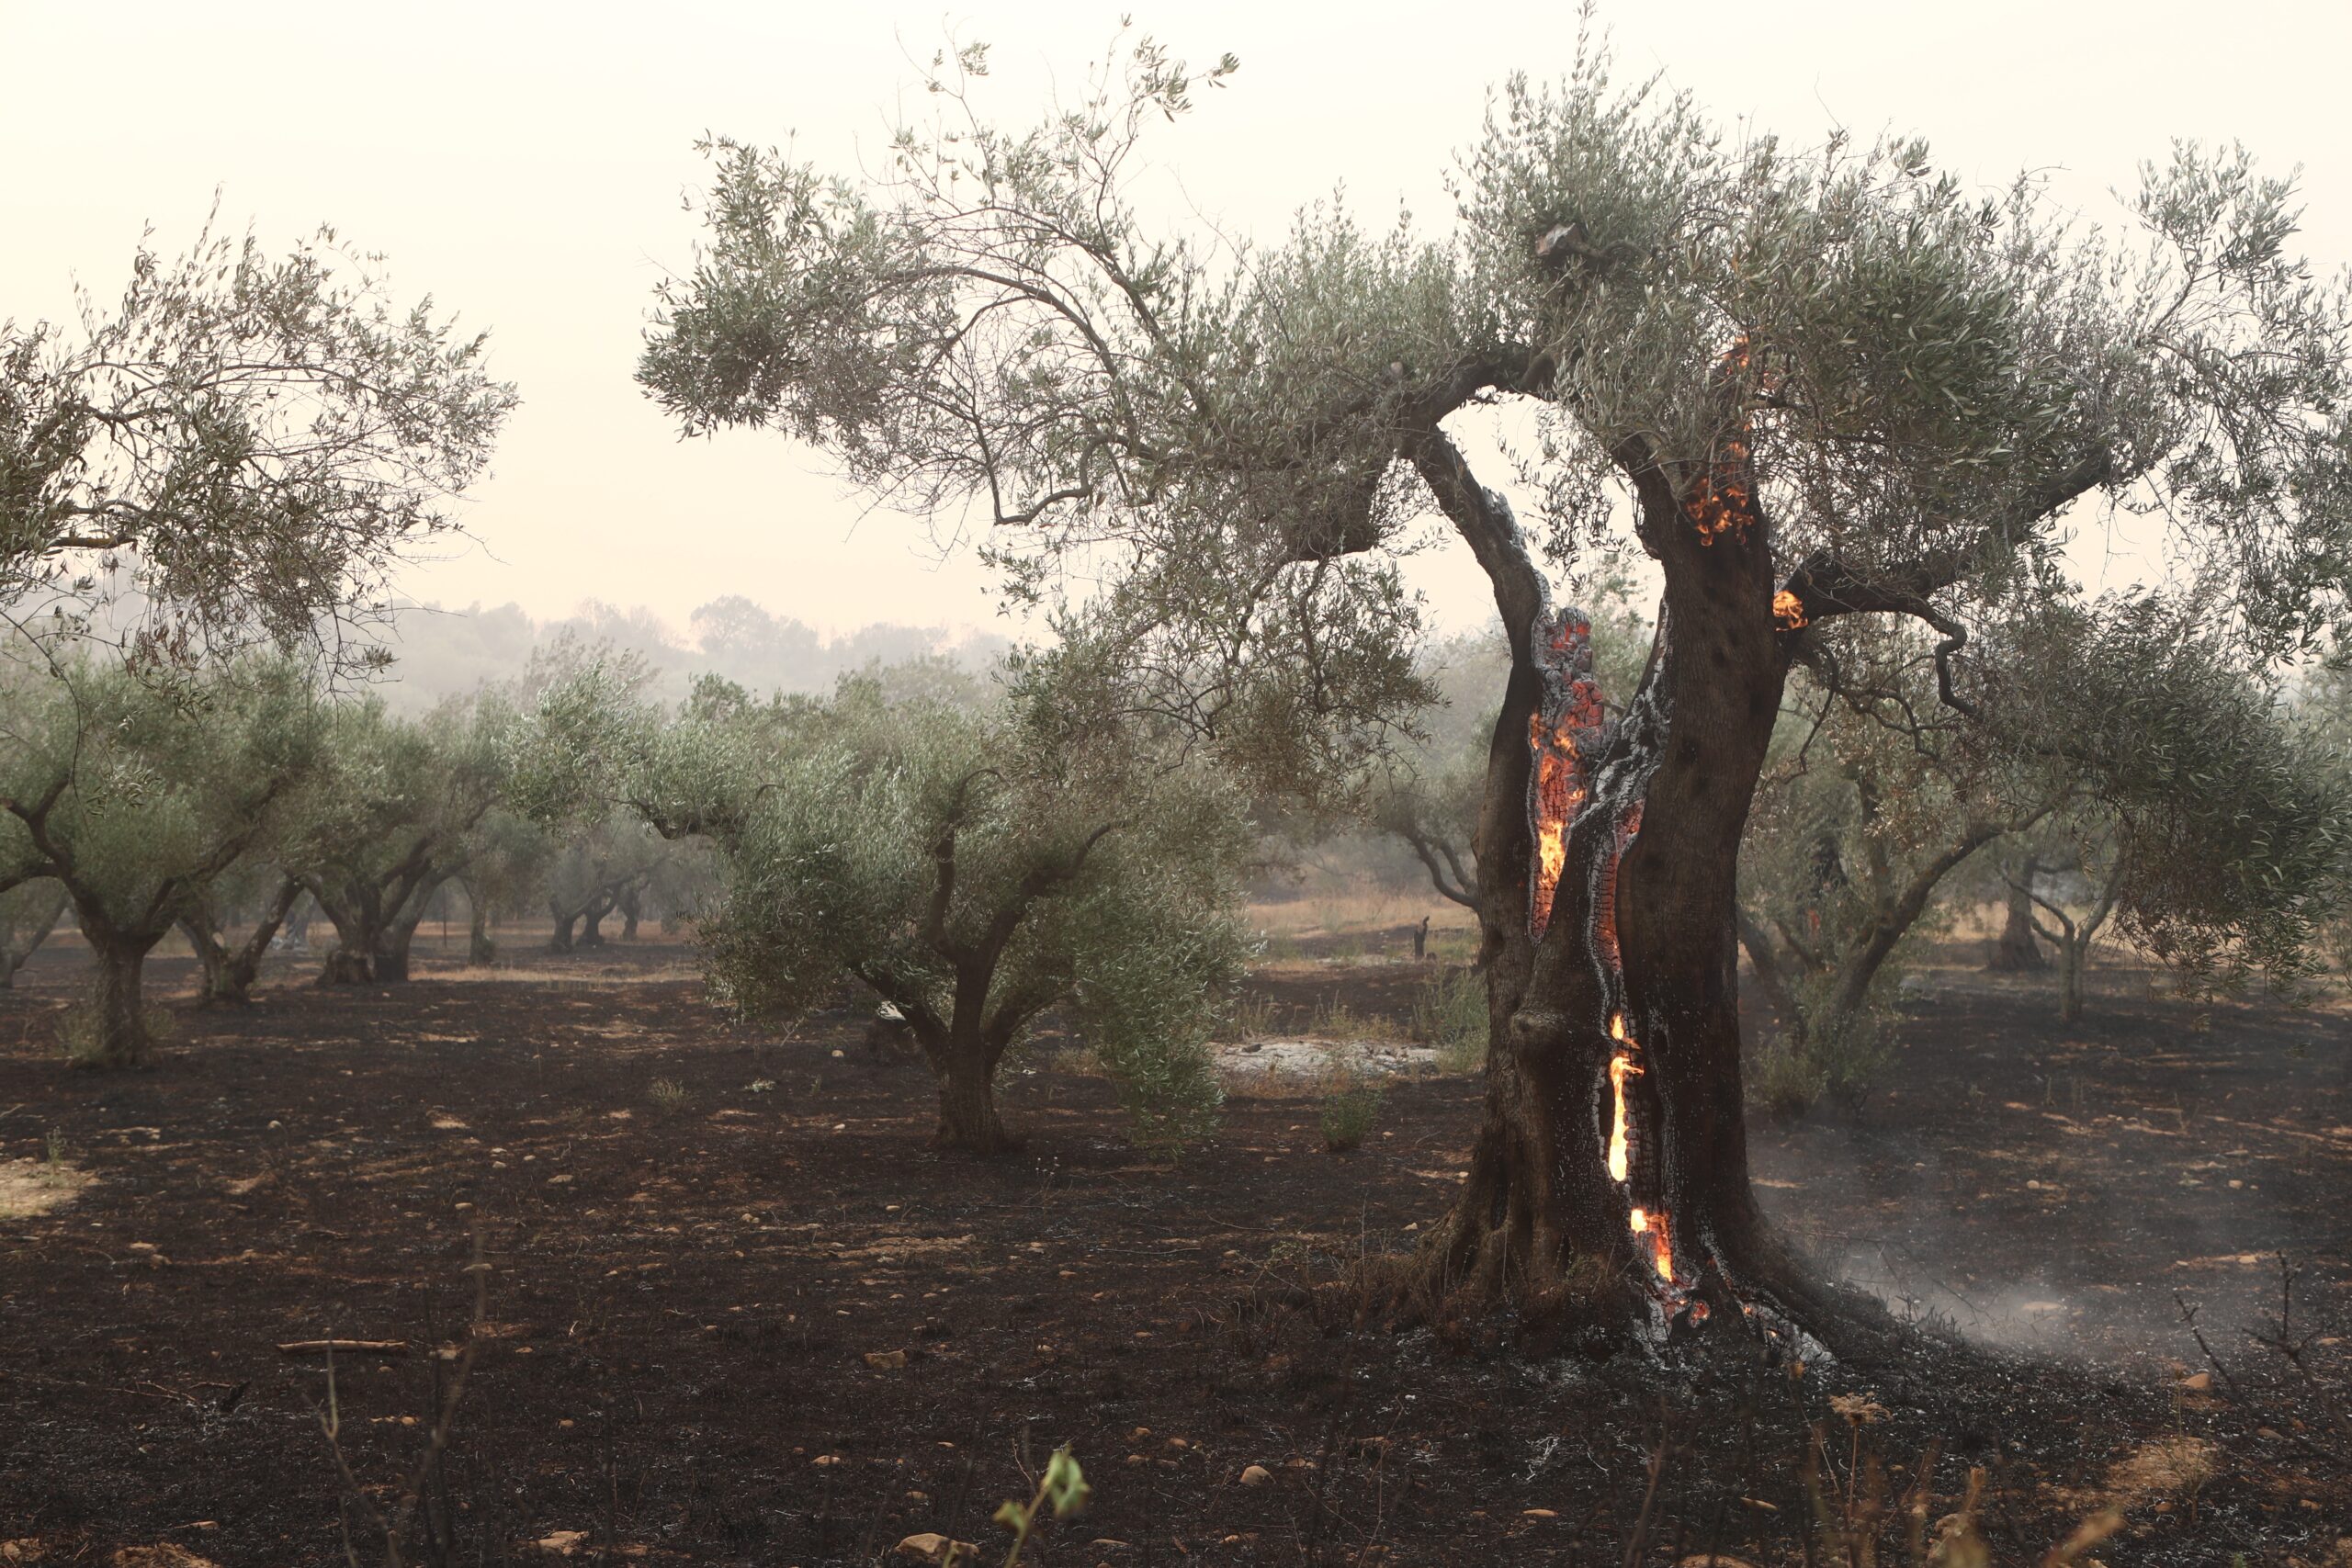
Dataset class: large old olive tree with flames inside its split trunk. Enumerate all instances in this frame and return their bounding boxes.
[639,45,2352,1347]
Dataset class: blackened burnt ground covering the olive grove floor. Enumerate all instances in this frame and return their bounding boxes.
[0,926,2352,1568]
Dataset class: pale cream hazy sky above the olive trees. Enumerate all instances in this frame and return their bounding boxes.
[0,0,2352,644]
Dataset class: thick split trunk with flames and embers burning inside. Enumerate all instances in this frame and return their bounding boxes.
[1407,446,1886,1354]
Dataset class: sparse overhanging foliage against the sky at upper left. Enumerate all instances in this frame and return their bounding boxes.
[0,207,515,659]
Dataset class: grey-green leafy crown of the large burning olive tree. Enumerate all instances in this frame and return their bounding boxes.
[639,28,2352,1020]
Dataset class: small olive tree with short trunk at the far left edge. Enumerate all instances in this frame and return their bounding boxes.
[0,660,324,1067]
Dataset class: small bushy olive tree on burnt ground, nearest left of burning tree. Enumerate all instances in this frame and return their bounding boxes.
[541,674,1253,1155]
